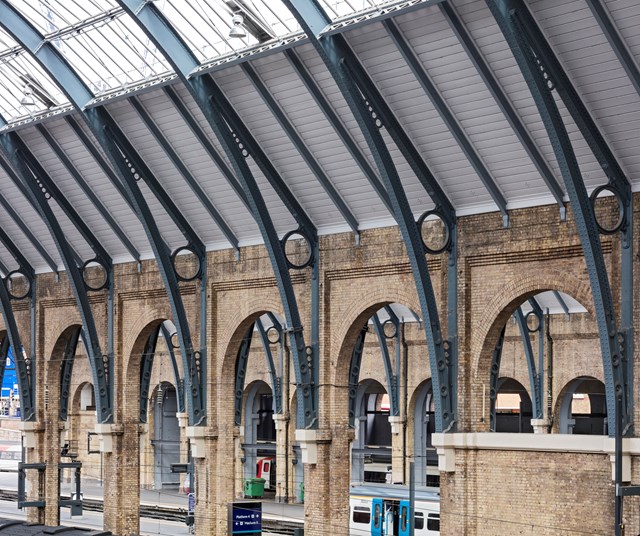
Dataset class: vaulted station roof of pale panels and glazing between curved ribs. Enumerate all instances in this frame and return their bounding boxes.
[0,0,640,273]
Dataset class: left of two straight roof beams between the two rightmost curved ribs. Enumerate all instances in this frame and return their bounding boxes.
[382,19,509,220]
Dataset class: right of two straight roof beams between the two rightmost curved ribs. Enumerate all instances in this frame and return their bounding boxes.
[438,1,566,215]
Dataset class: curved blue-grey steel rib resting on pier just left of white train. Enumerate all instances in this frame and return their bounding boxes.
[118,0,319,428]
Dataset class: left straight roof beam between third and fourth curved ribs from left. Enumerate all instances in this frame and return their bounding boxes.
[129,97,238,251]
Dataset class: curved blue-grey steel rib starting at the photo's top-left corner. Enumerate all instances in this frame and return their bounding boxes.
[0,5,206,425]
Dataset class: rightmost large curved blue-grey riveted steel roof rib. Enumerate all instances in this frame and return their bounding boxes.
[487,0,632,435]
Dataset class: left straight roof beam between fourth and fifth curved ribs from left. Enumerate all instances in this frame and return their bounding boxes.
[242,63,359,236]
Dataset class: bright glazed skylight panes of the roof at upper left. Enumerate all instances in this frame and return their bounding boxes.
[0,0,397,122]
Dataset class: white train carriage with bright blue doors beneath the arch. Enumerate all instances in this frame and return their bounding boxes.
[349,484,440,536]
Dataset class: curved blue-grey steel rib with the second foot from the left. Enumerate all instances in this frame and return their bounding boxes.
[0,134,113,423]
